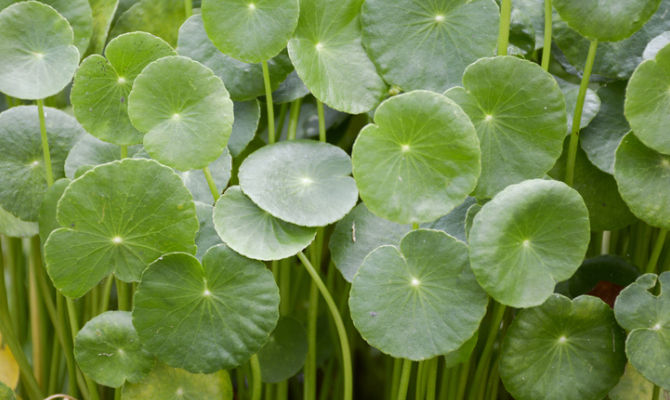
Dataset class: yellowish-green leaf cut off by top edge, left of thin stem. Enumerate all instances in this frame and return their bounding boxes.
[109,0,186,46]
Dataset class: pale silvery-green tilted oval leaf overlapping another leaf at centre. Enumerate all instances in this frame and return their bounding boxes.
[239,140,358,226]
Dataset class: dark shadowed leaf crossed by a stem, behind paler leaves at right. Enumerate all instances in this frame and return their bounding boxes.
[549,139,635,232]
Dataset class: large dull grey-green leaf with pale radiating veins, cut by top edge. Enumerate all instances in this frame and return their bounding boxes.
[361,0,499,92]
